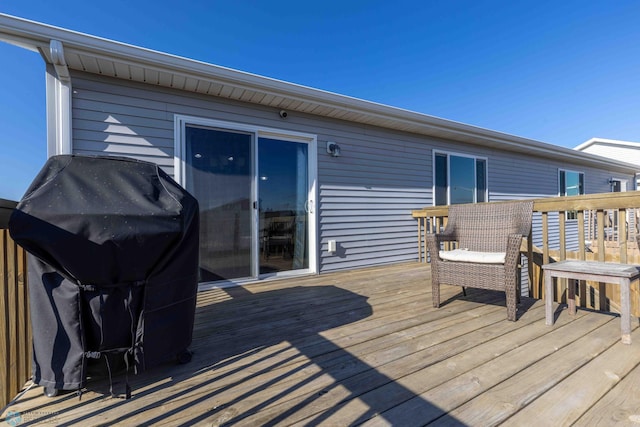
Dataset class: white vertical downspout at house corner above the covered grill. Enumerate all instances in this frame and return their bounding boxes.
[47,40,72,157]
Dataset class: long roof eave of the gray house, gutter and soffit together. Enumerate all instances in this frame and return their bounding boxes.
[0,14,635,172]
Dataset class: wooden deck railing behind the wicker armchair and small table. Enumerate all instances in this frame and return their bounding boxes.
[412,191,640,316]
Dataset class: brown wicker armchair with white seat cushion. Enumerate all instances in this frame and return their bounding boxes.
[427,201,533,321]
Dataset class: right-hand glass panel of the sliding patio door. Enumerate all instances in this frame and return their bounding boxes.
[258,138,309,274]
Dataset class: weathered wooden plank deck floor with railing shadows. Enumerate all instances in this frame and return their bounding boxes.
[3,263,640,426]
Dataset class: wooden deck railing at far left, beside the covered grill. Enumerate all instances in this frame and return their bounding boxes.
[0,199,31,407]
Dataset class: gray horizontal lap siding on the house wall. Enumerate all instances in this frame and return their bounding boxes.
[73,73,632,272]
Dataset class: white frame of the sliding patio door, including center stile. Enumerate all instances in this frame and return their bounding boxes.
[173,114,319,284]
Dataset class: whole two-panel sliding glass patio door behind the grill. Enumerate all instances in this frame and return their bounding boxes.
[177,118,315,282]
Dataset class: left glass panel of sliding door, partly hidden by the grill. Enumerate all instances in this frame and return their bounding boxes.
[184,125,254,282]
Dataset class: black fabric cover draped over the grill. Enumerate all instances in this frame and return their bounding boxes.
[9,155,199,390]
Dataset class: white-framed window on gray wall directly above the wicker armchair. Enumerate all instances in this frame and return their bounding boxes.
[434,153,487,206]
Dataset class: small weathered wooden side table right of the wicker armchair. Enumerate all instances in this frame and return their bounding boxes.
[542,260,640,344]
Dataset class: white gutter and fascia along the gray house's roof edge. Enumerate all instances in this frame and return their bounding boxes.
[0,14,636,174]
